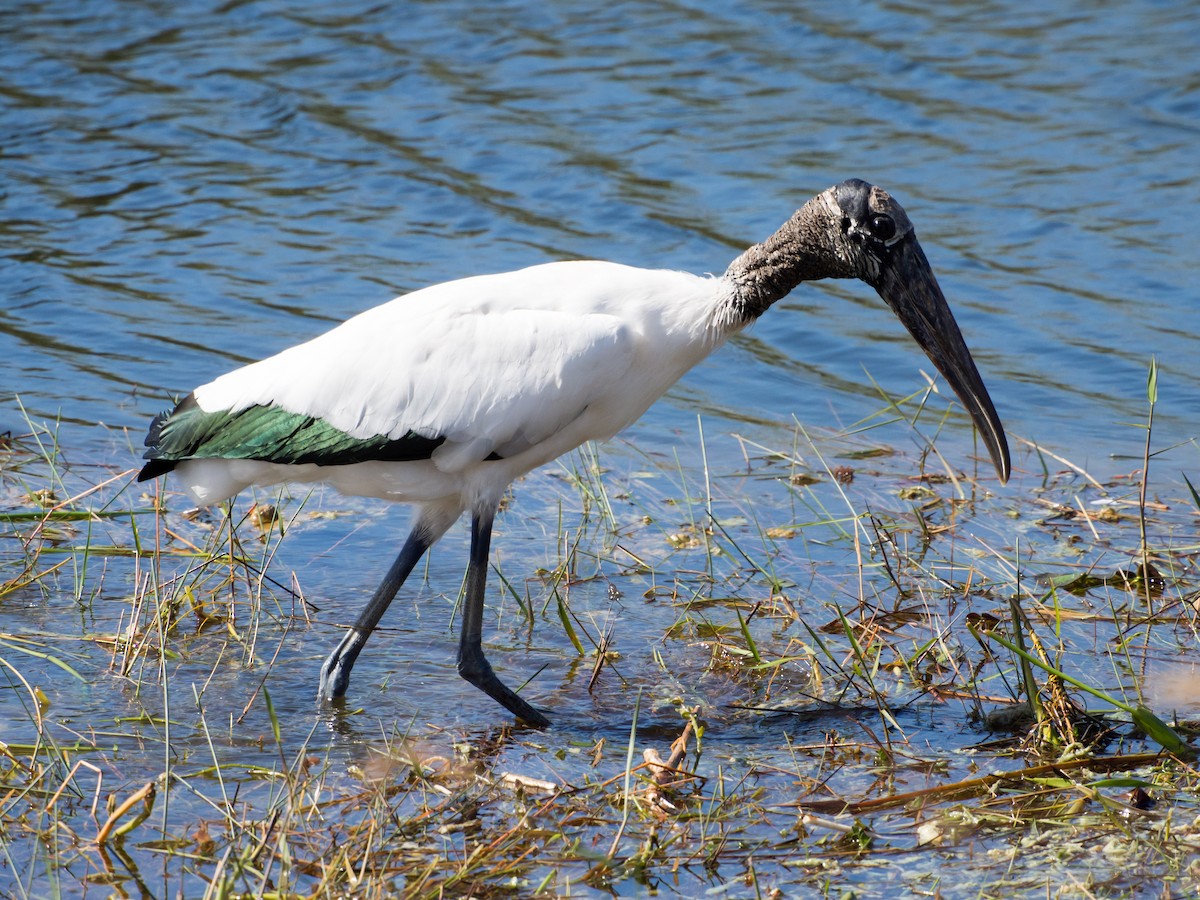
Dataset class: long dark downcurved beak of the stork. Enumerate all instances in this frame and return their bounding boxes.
[874,234,1012,481]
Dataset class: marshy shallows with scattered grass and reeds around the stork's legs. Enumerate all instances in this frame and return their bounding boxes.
[0,372,1200,898]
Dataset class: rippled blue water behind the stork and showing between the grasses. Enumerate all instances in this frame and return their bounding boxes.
[0,0,1200,897]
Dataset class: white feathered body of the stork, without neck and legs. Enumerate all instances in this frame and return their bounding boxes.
[157,262,738,512]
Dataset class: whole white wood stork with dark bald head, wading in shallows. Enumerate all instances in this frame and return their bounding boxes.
[138,179,1009,726]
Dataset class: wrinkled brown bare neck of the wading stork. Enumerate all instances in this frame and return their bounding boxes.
[725,194,853,324]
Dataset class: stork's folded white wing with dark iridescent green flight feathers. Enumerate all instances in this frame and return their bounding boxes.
[144,278,641,478]
